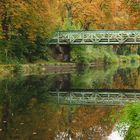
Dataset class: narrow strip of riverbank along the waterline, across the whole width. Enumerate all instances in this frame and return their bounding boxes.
[0,61,139,78]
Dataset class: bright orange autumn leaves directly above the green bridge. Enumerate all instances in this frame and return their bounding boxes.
[59,0,140,29]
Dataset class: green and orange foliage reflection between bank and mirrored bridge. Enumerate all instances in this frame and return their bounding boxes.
[71,66,140,89]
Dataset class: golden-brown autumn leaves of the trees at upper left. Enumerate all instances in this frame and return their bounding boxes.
[0,0,59,40]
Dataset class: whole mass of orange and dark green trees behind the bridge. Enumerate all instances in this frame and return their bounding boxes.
[0,0,140,62]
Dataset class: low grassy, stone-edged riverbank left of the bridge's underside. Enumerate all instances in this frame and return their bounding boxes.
[0,63,77,77]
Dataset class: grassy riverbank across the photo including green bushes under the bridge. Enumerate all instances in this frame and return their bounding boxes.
[0,46,140,77]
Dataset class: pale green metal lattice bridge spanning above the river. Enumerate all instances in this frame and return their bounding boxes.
[48,30,140,45]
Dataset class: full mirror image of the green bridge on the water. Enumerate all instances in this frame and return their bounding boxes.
[48,90,140,106]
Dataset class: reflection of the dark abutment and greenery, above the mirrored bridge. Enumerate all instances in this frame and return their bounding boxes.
[51,66,140,90]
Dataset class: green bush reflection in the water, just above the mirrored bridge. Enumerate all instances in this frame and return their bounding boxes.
[71,67,117,89]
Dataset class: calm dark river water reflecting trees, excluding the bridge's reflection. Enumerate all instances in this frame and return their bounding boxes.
[0,65,140,140]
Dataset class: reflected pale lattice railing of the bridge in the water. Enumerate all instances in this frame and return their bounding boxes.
[50,92,140,105]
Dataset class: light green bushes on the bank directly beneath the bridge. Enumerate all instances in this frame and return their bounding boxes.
[71,45,118,64]
